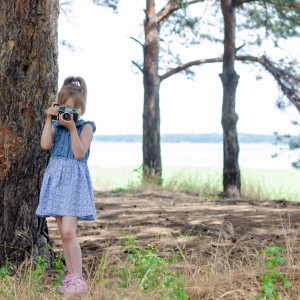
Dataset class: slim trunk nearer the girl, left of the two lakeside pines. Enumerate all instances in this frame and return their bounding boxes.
[143,0,162,184]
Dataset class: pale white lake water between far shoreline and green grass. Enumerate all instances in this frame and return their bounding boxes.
[89,142,299,169]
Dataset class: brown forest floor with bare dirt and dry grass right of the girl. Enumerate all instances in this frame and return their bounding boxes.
[42,188,300,300]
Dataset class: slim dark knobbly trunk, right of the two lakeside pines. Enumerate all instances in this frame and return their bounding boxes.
[220,0,241,198]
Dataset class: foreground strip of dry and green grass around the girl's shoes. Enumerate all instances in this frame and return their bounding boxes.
[0,236,300,300]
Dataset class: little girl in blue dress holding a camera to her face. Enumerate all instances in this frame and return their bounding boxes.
[36,77,96,293]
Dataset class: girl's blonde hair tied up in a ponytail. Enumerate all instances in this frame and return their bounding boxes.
[57,76,87,115]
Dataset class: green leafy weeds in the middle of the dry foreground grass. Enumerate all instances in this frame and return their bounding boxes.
[115,237,188,300]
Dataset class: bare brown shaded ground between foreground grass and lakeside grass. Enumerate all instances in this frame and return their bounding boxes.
[48,189,300,257]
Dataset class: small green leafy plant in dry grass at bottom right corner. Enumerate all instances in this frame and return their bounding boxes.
[255,247,292,300]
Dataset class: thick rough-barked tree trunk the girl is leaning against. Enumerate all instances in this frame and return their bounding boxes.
[0,0,59,265]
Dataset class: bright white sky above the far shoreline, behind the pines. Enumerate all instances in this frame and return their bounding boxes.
[58,0,299,135]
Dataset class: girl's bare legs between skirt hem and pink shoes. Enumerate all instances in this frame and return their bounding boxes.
[57,216,82,275]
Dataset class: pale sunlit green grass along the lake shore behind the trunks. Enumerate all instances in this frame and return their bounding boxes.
[91,168,300,201]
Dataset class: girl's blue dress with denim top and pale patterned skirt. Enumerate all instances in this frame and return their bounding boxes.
[36,120,96,220]
